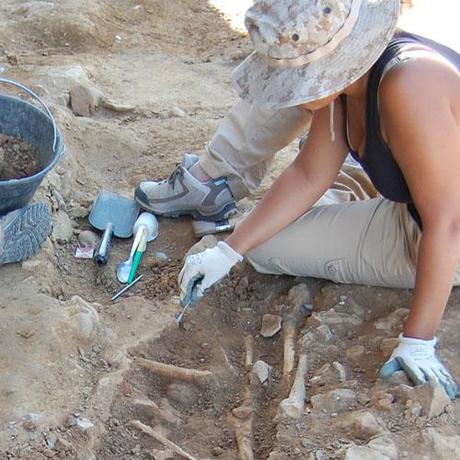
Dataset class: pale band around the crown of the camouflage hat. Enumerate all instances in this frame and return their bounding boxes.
[257,0,362,67]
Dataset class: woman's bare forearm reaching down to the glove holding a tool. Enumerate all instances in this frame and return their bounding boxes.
[226,101,348,254]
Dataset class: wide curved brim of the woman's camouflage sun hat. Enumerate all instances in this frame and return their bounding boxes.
[232,0,399,109]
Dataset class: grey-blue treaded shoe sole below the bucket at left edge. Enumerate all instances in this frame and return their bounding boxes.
[0,203,51,265]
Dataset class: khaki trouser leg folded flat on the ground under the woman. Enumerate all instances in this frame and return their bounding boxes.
[247,164,428,288]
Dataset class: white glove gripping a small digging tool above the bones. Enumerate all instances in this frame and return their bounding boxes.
[178,241,243,305]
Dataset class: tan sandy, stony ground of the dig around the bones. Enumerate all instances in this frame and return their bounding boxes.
[0,0,460,460]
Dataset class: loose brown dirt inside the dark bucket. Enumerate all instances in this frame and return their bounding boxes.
[0,134,43,181]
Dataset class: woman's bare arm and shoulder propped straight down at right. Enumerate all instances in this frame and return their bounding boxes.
[380,61,460,339]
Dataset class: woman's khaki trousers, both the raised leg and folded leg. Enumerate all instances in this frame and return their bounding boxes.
[200,100,460,288]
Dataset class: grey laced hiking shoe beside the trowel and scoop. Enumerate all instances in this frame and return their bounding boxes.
[134,153,237,221]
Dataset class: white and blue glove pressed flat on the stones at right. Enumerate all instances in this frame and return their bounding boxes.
[380,334,458,399]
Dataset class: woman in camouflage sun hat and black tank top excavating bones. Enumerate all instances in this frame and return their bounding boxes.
[179,0,460,398]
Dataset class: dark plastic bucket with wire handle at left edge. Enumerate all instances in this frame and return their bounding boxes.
[0,78,65,215]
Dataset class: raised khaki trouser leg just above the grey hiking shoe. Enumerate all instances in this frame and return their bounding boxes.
[200,100,311,201]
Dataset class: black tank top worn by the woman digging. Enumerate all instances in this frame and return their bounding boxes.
[342,31,460,228]
